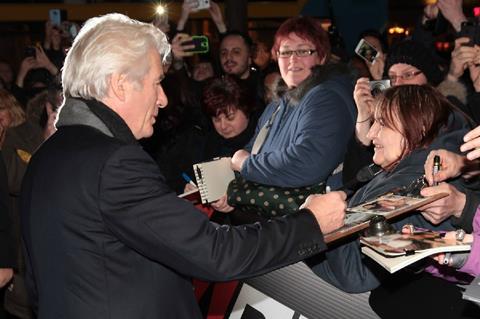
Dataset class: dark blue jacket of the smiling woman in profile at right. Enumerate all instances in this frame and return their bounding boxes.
[310,114,470,293]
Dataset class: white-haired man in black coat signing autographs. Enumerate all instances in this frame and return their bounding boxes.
[21,14,345,319]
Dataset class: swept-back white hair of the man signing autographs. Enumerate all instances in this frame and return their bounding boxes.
[62,13,170,101]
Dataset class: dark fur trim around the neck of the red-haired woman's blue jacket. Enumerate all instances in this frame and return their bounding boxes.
[273,63,353,106]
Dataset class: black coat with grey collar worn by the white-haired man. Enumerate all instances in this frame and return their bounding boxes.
[21,99,325,319]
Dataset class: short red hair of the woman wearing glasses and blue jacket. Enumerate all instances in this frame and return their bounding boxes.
[272,17,330,61]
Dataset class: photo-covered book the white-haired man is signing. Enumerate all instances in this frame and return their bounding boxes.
[324,190,448,243]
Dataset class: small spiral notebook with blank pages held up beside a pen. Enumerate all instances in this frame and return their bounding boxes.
[193,157,235,204]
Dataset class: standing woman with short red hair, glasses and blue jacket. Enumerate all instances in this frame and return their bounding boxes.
[211,17,356,211]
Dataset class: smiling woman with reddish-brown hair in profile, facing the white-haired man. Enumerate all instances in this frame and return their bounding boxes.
[311,85,478,318]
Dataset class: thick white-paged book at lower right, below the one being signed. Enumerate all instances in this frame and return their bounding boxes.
[360,231,470,273]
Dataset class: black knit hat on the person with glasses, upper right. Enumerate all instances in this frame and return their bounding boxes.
[385,40,444,86]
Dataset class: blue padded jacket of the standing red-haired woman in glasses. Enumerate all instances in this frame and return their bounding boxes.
[240,66,356,187]
